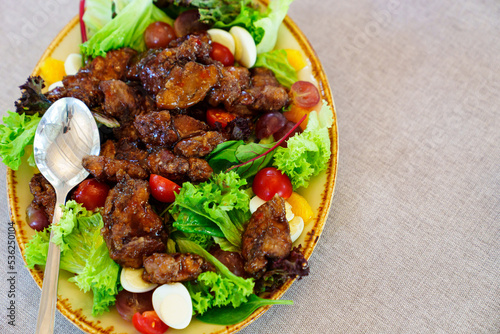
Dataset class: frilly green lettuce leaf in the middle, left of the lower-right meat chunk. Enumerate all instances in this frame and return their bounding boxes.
[170,172,250,248]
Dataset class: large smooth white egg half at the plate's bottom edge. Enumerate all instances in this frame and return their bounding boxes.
[153,283,193,329]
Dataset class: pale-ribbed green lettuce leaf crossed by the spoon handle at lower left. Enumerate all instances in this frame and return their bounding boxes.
[25,201,120,316]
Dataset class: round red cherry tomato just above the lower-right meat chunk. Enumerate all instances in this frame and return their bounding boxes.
[252,167,293,201]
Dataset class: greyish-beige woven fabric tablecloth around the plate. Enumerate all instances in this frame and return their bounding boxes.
[0,0,500,333]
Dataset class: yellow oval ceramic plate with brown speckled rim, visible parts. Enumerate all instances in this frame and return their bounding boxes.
[7,1,338,333]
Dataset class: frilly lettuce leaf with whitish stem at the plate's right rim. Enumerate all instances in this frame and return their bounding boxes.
[273,101,333,189]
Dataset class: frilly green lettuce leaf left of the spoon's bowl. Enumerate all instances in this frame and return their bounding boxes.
[0,111,41,170]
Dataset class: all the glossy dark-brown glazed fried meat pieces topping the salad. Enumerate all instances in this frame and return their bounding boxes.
[30,32,291,283]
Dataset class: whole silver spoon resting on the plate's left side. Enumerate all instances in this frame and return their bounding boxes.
[33,97,100,334]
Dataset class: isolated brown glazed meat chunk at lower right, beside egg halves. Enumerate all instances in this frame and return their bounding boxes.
[241,195,292,276]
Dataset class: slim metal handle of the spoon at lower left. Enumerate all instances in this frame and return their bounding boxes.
[36,192,66,334]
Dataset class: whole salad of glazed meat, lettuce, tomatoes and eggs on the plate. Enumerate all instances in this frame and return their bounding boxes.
[0,0,334,333]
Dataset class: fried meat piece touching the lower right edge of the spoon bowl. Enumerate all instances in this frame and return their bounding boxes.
[82,155,149,182]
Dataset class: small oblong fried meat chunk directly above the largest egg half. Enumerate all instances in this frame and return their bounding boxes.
[142,253,214,284]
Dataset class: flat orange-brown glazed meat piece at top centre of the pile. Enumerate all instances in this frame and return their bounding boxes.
[156,62,219,109]
